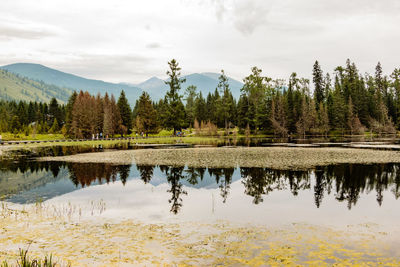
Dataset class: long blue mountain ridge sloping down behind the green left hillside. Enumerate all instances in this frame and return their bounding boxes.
[1,63,142,103]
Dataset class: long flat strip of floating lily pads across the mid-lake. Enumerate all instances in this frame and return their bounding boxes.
[38,147,400,170]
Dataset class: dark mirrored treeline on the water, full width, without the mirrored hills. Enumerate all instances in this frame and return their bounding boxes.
[0,161,400,214]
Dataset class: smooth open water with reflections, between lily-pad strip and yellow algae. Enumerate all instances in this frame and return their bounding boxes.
[0,161,400,228]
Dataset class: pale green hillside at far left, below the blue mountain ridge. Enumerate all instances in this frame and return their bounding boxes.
[0,69,72,103]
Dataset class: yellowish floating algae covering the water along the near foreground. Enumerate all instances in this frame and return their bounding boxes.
[0,205,400,266]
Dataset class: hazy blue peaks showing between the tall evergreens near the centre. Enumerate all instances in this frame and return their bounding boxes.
[135,72,243,99]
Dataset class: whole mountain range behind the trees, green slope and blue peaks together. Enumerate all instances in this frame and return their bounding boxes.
[0,63,243,104]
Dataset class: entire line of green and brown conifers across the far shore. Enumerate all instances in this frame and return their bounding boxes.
[0,59,400,137]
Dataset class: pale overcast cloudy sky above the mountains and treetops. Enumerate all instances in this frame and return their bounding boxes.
[0,0,400,83]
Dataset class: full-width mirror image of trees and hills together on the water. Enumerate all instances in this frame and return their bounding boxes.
[0,161,400,214]
